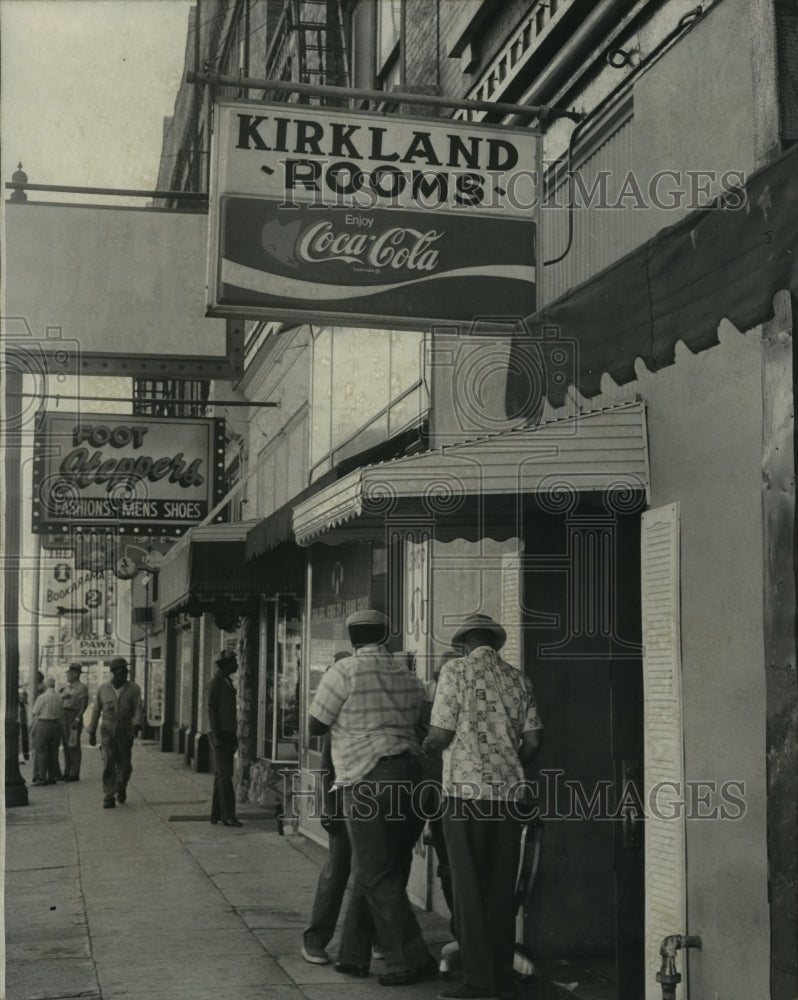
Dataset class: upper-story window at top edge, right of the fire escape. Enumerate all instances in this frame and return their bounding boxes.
[347,0,402,90]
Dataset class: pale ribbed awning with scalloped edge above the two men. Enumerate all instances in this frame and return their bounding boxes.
[293,401,649,545]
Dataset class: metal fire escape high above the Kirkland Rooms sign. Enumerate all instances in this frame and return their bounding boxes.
[264,0,349,104]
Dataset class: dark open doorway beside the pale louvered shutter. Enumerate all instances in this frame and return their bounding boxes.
[523,501,644,1000]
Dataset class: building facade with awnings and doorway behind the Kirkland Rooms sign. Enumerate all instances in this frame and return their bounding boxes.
[159,0,798,1000]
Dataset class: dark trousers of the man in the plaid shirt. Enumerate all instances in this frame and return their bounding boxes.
[338,754,431,972]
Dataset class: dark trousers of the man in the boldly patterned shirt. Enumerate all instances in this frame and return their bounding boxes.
[443,798,521,992]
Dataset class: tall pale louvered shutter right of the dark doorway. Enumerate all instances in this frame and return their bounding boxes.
[641,504,687,1000]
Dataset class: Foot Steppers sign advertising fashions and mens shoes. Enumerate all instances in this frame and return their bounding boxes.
[32,412,224,535]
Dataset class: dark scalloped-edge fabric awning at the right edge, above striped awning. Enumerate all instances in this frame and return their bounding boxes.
[505,146,798,416]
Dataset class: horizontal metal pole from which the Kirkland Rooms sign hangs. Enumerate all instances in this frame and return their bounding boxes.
[186,70,582,121]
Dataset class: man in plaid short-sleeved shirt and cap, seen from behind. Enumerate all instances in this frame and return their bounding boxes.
[310,610,437,986]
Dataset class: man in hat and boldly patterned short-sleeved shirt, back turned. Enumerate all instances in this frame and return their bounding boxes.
[424,614,542,1000]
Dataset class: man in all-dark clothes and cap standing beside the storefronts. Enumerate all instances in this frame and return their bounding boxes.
[208,649,243,826]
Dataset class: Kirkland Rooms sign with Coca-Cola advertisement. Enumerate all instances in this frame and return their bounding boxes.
[208,102,539,327]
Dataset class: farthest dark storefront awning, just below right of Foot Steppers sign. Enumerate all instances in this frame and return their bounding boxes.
[159,521,260,614]
